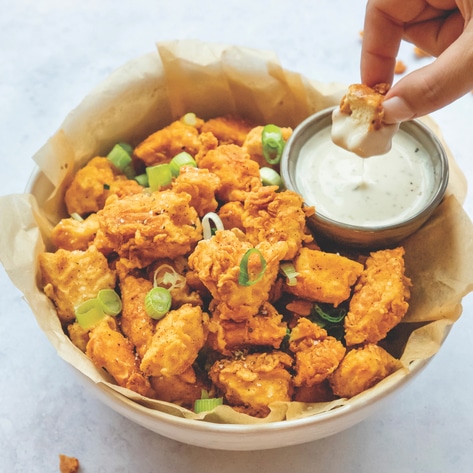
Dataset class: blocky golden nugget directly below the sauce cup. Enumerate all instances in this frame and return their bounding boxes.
[286,248,363,307]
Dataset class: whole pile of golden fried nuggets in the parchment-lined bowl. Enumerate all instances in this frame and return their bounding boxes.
[39,116,411,417]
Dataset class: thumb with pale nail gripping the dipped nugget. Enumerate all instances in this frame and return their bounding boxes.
[383,28,473,123]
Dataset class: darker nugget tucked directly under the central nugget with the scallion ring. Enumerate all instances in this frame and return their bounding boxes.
[207,302,287,356]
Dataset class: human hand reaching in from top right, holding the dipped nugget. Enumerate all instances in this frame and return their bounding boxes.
[361,0,473,123]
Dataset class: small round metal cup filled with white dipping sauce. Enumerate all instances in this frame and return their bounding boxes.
[281,108,449,249]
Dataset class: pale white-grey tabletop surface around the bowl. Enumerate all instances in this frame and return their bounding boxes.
[0,0,473,473]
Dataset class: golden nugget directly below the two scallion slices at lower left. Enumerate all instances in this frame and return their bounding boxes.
[86,317,151,396]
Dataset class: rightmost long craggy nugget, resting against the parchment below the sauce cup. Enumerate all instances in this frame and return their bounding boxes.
[345,247,411,345]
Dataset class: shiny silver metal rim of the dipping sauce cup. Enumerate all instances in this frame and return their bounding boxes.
[280,106,450,234]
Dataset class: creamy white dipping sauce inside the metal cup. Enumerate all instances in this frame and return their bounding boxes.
[295,127,434,227]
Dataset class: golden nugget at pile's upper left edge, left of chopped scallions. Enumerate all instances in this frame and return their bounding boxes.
[64,156,142,216]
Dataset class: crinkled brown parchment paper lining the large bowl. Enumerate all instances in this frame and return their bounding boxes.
[0,40,473,424]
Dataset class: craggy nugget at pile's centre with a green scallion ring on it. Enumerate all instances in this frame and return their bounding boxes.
[189,229,287,322]
